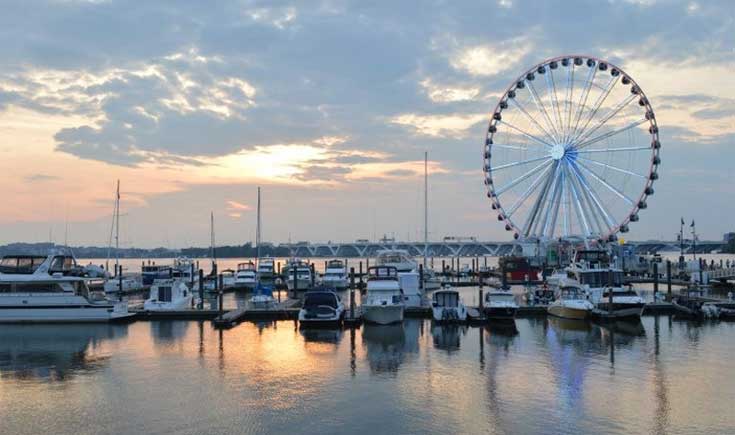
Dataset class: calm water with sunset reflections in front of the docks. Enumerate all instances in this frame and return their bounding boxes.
[0,317,735,434]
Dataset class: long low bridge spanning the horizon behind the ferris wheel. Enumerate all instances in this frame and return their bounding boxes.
[280,240,725,258]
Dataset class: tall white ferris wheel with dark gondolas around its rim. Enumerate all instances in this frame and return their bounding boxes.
[483,56,661,241]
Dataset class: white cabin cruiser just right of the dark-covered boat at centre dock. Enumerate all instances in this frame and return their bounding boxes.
[362,266,405,325]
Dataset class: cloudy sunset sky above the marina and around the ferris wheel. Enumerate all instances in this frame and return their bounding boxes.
[0,0,735,248]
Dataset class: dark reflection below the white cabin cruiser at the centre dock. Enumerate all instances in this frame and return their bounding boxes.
[362,319,423,373]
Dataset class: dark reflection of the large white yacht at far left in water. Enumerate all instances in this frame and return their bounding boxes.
[0,324,128,382]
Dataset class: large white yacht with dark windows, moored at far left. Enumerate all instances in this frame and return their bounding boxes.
[0,255,132,323]
